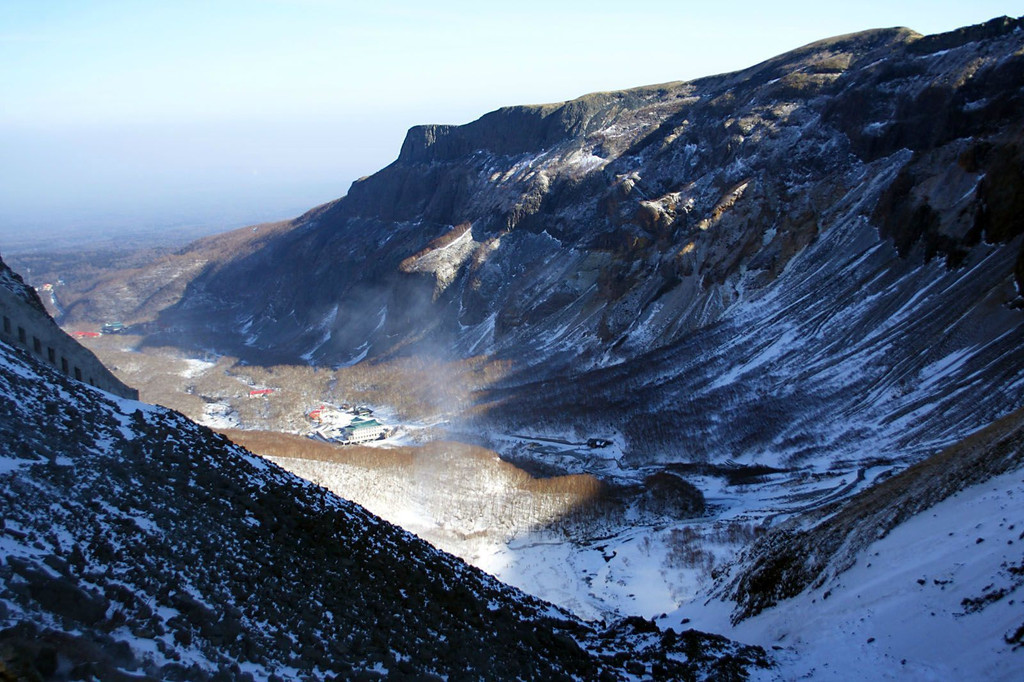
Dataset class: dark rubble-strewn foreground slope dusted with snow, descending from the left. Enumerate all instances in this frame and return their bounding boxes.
[0,301,766,680]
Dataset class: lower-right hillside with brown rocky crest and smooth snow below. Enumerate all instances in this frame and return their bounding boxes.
[684,405,1024,680]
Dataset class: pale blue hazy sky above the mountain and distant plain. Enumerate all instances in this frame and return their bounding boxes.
[0,0,1024,251]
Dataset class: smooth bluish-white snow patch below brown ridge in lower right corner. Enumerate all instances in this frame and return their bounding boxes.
[679,469,1024,682]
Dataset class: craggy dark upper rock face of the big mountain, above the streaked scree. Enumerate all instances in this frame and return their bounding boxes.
[159,19,1024,365]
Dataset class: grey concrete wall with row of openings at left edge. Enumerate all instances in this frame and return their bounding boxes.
[0,260,138,399]
